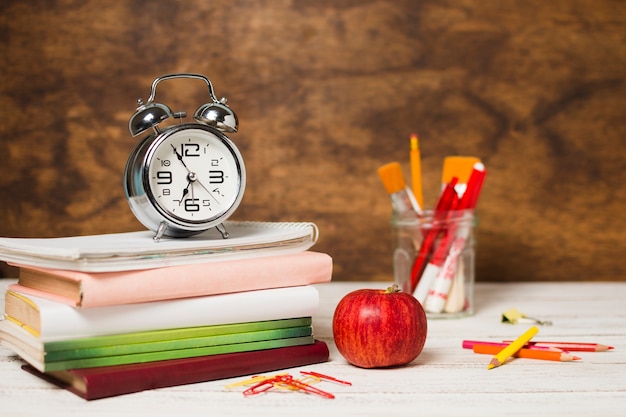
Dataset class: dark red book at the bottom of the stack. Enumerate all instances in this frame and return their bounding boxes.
[22,341,329,400]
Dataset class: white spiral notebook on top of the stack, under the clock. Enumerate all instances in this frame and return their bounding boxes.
[0,221,318,272]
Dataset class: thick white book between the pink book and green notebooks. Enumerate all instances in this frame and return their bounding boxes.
[0,286,319,342]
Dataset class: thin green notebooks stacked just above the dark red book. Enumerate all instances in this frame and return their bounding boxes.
[0,317,313,372]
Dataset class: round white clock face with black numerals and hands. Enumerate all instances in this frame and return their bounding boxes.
[144,125,245,224]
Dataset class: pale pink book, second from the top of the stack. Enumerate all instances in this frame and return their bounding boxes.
[9,251,332,307]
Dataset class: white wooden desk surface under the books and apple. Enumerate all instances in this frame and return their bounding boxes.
[0,282,626,417]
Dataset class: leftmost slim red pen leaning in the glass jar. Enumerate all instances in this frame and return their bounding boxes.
[411,177,459,294]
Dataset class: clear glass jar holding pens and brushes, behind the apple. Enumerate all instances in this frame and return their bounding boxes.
[391,210,476,318]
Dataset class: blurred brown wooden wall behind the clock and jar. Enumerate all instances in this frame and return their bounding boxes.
[0,0,626,281]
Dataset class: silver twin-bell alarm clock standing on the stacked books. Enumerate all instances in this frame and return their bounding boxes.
[124,74,246,241]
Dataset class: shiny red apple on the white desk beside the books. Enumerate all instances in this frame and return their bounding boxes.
[333,285,427,368]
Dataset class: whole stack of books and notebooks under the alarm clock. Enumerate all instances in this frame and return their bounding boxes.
[0,221,332,400]
